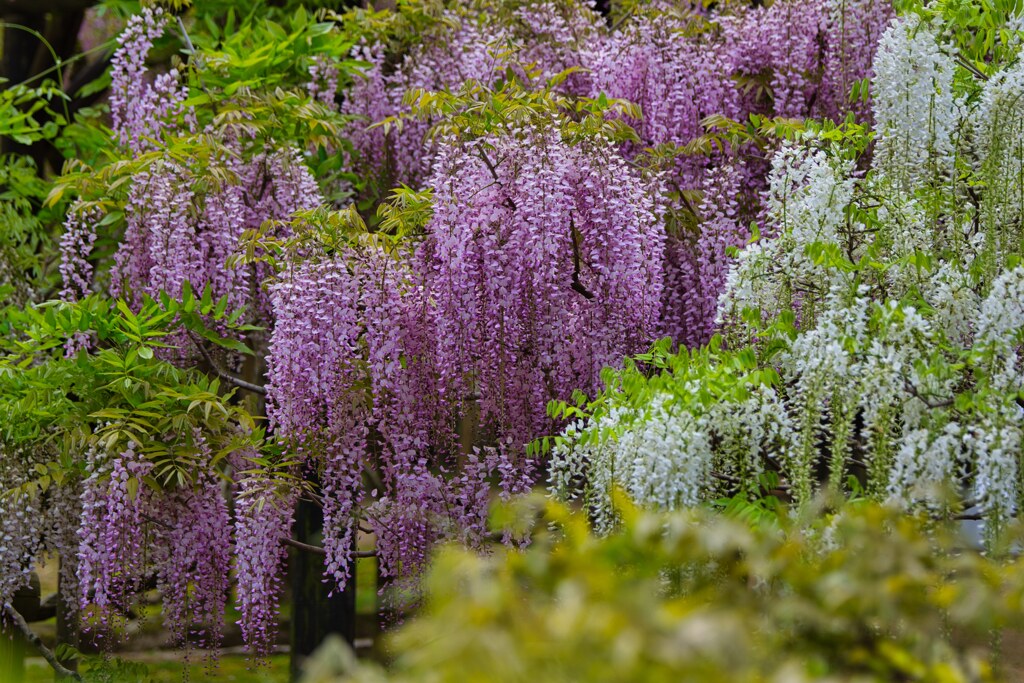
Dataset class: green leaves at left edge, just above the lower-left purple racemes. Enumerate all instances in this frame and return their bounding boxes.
[0,288,262,497]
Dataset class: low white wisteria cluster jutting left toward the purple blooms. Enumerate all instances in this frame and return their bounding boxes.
[551,380,795,530]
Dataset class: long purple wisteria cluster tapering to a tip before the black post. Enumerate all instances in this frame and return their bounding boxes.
[267,255,371,587]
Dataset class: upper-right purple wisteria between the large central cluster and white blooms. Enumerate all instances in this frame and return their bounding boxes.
[587,0,891,346]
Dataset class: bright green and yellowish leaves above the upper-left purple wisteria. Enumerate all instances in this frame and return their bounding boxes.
[49,3,361,219]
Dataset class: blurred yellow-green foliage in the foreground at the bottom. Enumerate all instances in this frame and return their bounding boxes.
[306,499,1024,683]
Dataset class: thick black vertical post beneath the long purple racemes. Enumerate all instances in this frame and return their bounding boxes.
[290,493,355,681]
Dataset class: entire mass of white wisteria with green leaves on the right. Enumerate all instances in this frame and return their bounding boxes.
[552,7,1024,529]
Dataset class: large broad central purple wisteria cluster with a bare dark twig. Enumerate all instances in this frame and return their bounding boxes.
[422,126,665,435]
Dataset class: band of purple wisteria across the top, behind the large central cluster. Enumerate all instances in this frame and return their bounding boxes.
[342,0,893,345]
